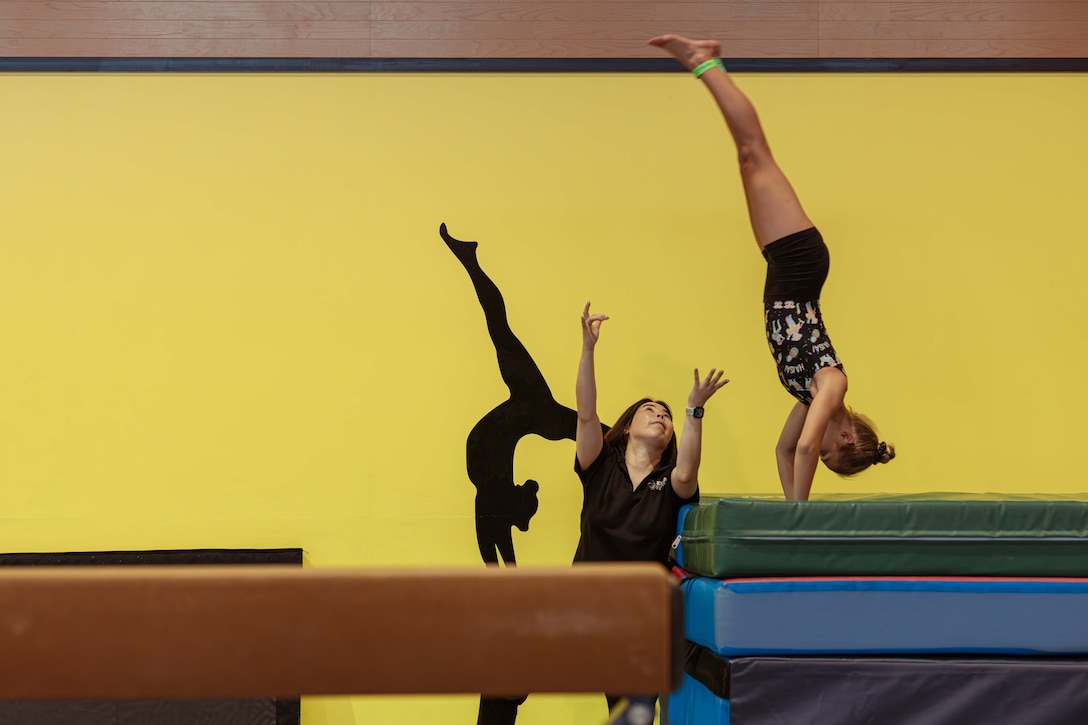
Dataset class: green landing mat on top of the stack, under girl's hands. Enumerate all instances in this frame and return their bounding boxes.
[676,493,1088,578]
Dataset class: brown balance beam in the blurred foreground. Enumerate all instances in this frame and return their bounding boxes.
[0,564,683,700]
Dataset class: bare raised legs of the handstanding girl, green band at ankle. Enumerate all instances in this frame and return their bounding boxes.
[650,35,813,250]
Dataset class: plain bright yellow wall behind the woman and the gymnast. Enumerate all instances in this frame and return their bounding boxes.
[0,74,1088,725]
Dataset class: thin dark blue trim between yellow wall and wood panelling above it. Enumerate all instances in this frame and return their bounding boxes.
[6,58,1088,73]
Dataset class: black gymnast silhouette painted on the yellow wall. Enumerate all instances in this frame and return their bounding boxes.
[438,219,578,566]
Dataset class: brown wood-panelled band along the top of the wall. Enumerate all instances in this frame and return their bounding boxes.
[0,0,1088,58]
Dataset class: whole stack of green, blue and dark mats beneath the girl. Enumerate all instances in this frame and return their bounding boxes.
[663,494,1088,725]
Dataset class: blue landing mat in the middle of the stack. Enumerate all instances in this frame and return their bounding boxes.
[681,577,1088,653]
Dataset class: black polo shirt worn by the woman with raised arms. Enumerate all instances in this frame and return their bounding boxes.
[574,443,698,565]
